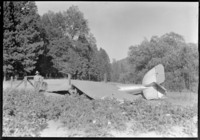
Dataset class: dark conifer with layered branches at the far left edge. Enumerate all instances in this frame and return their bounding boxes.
[3,1,44,79]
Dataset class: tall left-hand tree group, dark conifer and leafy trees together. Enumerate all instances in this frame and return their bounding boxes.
[3,1,111,81]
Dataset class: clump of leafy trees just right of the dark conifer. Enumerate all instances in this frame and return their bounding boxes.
[33,6,110,81]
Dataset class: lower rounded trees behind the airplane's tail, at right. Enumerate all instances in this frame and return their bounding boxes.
[112,32,199,92]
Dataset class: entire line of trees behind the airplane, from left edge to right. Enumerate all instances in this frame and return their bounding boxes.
[3,1,199,91]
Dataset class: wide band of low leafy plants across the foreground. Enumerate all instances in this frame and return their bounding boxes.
[3,90,197,137]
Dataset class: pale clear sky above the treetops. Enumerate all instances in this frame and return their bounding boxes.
[35,1,199,62]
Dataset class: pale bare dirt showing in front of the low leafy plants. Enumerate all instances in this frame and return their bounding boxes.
[40,120,197,137]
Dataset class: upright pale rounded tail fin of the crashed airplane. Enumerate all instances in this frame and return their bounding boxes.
[142,64,166,99]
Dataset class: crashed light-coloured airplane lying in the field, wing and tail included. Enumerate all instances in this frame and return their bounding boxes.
[48,64,167,101]
